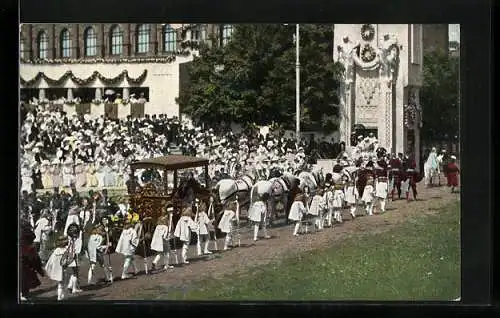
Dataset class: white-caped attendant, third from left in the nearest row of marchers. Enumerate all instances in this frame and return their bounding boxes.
[87,225,112,285]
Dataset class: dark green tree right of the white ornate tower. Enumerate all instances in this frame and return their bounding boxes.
[420,52,460,140]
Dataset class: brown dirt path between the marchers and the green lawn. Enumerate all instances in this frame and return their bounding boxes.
[27,185,459,301]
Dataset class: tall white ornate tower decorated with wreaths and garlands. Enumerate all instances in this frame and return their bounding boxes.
[334,24,423,165]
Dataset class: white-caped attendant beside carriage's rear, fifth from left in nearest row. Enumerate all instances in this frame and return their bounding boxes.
[151,211,174,271]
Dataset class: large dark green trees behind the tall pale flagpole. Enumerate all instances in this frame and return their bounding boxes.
[177,24,341,131]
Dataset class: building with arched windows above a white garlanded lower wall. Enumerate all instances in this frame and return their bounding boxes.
[19,23,233,118]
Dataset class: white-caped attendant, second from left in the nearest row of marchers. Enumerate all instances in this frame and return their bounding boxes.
[65,223,82,294]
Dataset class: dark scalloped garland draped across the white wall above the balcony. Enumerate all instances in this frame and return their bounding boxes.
[20,70,148,86]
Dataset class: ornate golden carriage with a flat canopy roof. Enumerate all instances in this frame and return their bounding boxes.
[128,155,210,264]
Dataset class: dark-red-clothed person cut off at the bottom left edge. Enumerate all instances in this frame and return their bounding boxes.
[20,227,45,300]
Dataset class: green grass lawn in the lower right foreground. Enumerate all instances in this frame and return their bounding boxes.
[137,202,460,300]
